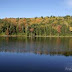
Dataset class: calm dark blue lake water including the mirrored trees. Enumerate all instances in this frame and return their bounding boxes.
[0,37,72,72]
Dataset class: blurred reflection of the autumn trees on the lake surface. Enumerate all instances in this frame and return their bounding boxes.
[0,37,72,56]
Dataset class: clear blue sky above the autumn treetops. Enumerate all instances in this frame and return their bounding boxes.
[0,0,72,18]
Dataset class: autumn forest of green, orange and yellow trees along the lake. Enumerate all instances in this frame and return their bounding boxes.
[0,15,72,37]
